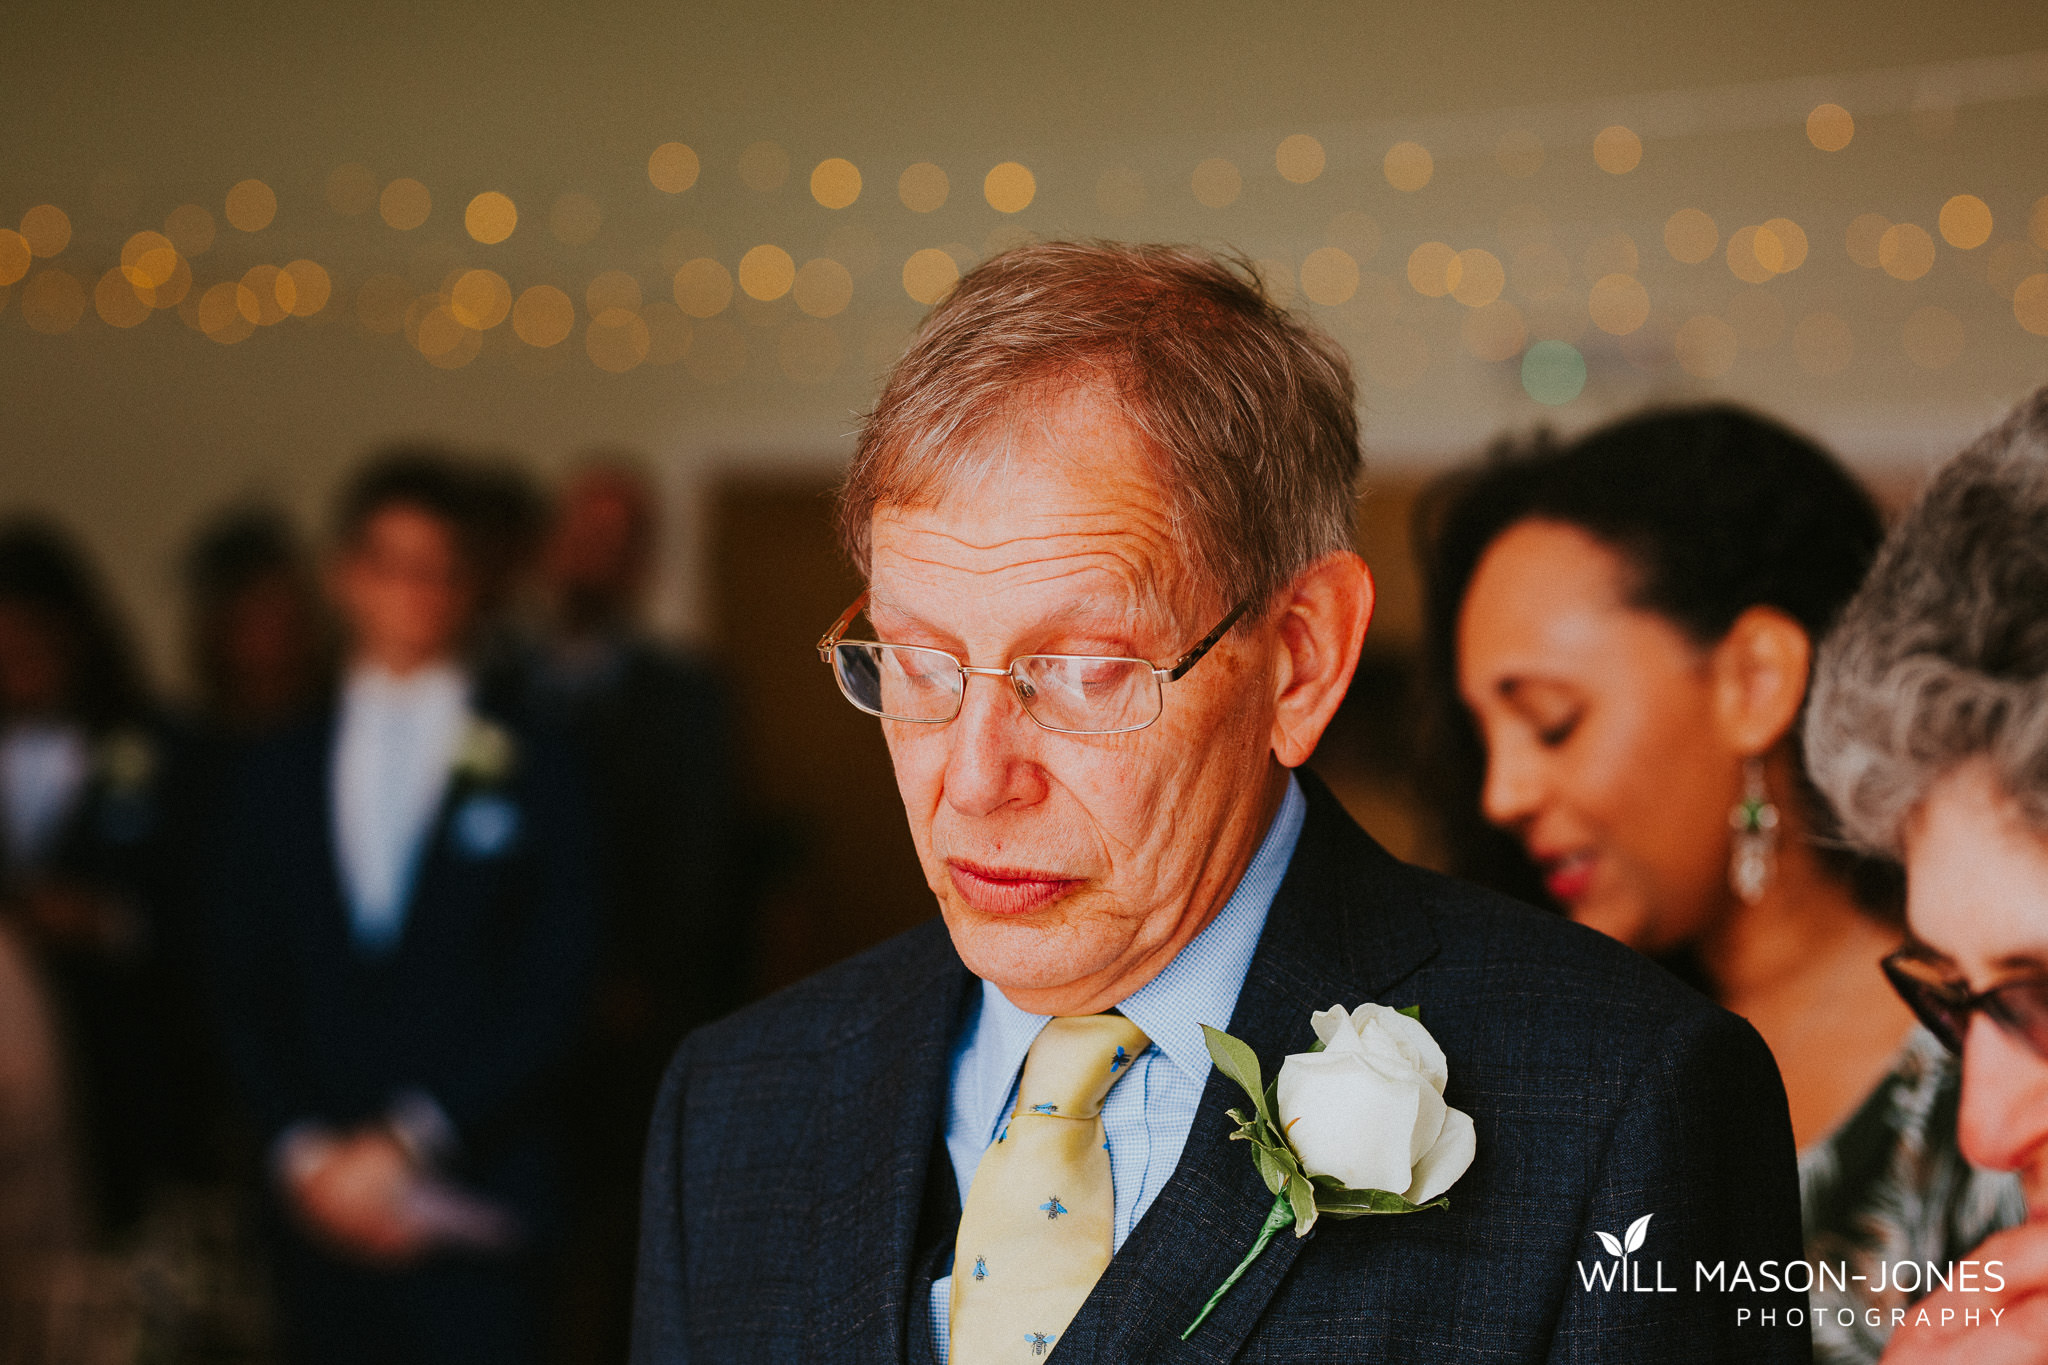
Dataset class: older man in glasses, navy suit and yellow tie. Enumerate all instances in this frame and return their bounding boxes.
[635,246,1808,1365]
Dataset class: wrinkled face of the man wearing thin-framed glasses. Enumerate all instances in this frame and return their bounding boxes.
[868,391,1282,1013]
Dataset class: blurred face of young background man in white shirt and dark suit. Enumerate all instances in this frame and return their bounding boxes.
[334,503,473,673]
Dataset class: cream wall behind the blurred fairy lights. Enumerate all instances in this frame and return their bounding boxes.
[0,0,2048,683]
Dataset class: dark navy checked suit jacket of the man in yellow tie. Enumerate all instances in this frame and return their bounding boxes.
[633,778,1808,1365]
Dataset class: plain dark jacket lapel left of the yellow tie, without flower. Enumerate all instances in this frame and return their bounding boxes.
[811,923,971,1361]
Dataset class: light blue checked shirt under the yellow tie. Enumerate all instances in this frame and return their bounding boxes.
[932,778,1309,1365]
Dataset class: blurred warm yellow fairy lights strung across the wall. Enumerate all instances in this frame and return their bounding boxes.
[0,104,2048,403]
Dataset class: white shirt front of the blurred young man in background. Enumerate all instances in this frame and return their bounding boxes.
[334,663,469,952]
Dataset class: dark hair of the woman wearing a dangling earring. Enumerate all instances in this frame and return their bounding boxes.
[1415,403,1901,917]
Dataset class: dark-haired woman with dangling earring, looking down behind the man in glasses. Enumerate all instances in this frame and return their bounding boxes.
[1421,407,2021,1363]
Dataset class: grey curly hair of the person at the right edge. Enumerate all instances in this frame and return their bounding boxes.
[1806,389,2048,853]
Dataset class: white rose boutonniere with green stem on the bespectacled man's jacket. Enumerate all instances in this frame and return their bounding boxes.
[1180,1005,1477,1340]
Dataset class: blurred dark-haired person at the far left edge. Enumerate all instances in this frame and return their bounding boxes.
[0,518,166,1228]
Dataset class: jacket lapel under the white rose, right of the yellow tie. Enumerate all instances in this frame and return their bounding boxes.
[1057,774,1438,1365]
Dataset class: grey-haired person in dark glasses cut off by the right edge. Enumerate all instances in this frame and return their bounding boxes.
[1806,378,2048,1365]
